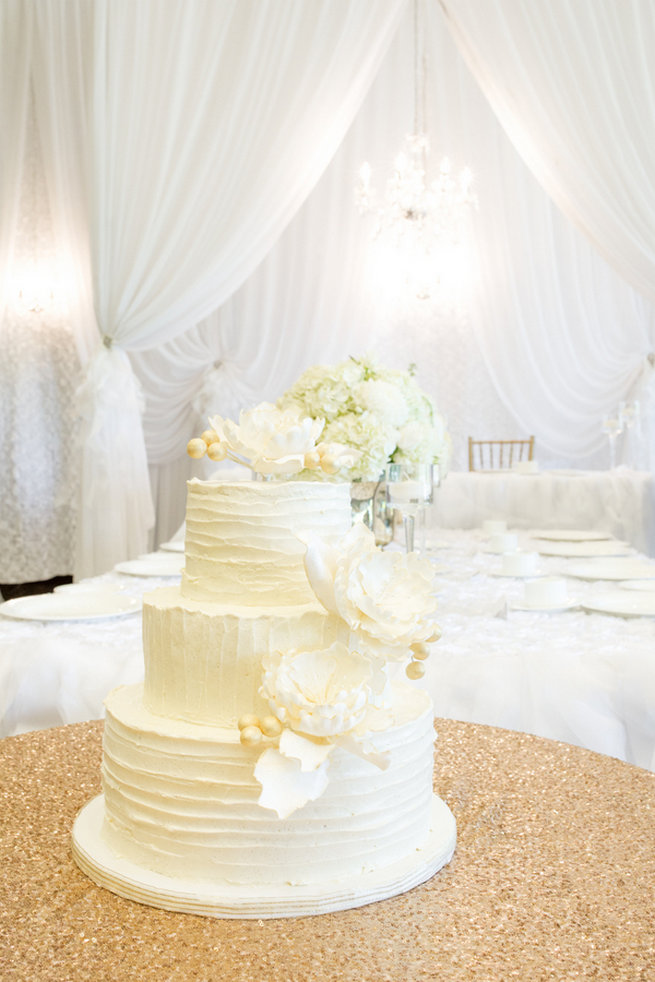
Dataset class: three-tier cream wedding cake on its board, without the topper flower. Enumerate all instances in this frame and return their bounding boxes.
[73,404,455,918]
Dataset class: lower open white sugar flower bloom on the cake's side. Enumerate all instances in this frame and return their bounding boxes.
[260,641,372,737]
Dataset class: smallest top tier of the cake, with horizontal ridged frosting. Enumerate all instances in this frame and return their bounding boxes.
[182,479,351,607]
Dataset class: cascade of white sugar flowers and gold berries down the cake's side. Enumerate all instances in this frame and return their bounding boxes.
[239,523,440,818]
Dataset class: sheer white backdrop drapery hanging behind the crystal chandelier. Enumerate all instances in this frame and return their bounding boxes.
[133,4,655,537]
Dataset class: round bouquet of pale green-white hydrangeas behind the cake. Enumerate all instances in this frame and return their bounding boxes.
[277,358,451,481]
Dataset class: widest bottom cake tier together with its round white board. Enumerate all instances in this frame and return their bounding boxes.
[74,686,455,917]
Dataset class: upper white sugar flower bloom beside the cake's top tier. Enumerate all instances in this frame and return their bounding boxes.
[305,522,436,660]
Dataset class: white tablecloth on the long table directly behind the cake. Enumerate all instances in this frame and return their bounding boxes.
[0,530,655,770]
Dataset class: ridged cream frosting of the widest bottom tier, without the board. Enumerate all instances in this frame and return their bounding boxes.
[103,685,434,889]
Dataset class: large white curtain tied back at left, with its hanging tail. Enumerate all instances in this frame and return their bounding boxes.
[34,0,404,577]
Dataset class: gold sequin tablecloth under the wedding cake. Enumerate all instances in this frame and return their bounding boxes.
[0,720,655,982]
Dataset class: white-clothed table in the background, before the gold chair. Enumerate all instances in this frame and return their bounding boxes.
[433,466,655,556]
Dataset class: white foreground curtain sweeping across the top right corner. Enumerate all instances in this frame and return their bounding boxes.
[441,0,655,302]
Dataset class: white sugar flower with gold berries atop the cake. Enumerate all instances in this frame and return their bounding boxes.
[187,402,355,477]
